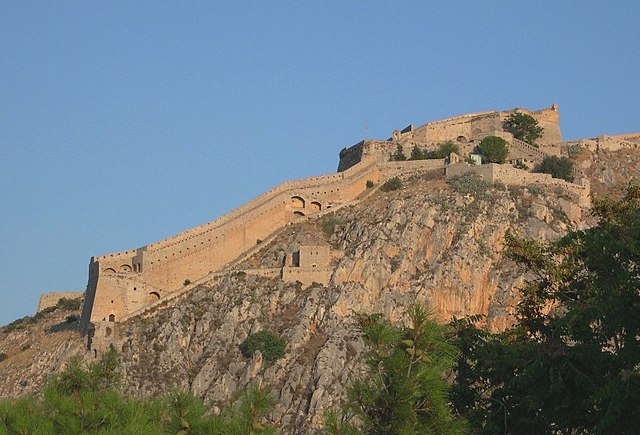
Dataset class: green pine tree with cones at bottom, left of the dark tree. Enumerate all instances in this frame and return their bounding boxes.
[325,305,466,434]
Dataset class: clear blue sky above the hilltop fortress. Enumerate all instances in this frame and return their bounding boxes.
[0,0,640,324]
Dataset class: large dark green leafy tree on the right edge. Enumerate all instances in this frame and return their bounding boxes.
[453,185,640,434]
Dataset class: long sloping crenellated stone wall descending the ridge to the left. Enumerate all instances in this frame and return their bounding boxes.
[81,155,390,330]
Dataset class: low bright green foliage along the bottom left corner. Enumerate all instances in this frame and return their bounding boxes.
[0,352,276,435]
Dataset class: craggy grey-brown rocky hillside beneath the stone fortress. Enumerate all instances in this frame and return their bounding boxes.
[0,147,640,433]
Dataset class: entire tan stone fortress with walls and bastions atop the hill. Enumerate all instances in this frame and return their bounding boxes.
[76,104,640,354]
